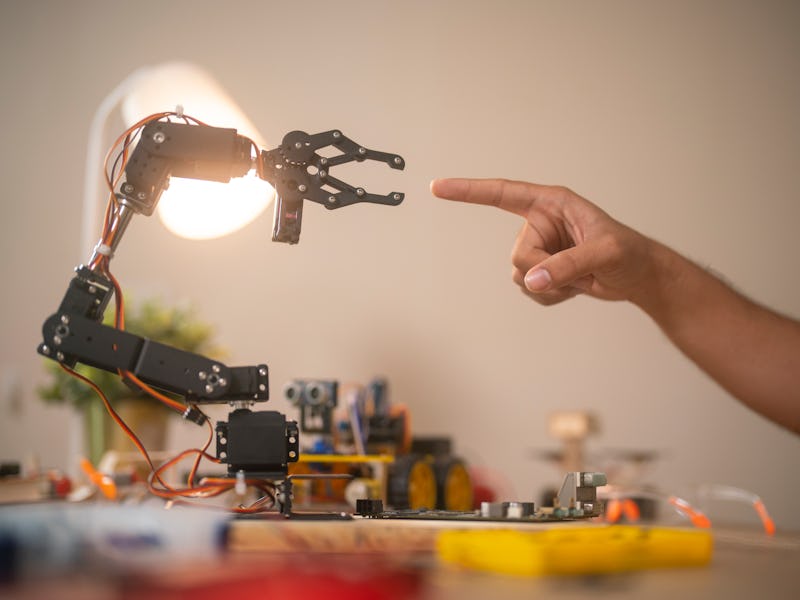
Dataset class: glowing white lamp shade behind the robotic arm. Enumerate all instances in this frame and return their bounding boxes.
[120,62,275,239]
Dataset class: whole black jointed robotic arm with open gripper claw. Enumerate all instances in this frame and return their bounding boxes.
[38,118,405,478]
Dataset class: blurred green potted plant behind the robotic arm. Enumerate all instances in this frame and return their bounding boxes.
[37,298,223,464]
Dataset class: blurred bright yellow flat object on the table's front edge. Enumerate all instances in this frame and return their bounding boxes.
[436,525,713,576]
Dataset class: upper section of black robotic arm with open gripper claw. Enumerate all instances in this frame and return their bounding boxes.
[115,121,405,244]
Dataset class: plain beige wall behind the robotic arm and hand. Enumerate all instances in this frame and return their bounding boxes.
[0,0,800,529]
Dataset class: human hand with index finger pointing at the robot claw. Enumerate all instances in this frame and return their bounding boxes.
[431,179,657,304]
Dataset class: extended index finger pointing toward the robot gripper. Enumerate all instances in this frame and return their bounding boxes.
[431,178,544,217]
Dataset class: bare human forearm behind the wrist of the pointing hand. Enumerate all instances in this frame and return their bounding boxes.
[630,242,800,432]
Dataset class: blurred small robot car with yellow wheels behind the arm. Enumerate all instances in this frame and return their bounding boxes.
[284,378,473,511]
